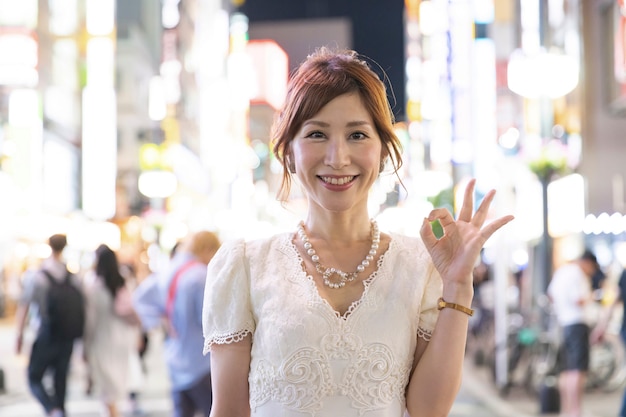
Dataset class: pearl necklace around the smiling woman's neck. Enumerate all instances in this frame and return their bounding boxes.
[297,220,380,288]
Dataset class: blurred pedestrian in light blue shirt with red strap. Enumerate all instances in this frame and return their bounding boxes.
[134,231,220,417]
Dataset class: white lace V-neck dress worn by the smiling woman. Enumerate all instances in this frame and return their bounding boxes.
[202,233,442,417]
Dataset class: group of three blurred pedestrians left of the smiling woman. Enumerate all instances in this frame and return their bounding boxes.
[7,231,221,417]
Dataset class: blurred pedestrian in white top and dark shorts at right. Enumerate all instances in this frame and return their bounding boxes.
[548,250,598,417]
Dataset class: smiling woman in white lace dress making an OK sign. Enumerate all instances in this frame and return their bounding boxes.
[203,48,512,417]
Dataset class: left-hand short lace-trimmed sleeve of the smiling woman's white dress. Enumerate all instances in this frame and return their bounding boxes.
[202,240,255,354]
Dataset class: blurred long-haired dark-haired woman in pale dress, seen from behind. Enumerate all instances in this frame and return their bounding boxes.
[84,245,139,417]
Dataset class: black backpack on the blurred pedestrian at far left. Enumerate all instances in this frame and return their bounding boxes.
[42,270,85,340]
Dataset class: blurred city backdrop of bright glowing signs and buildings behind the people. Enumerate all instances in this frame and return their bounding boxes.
[0,0,626,417]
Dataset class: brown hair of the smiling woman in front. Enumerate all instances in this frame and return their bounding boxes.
[271,47,402,201]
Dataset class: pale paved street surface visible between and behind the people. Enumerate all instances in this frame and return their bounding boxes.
[0,320,621,417]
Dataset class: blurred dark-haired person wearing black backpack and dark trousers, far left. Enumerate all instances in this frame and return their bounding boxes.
[16,234,85,417]
